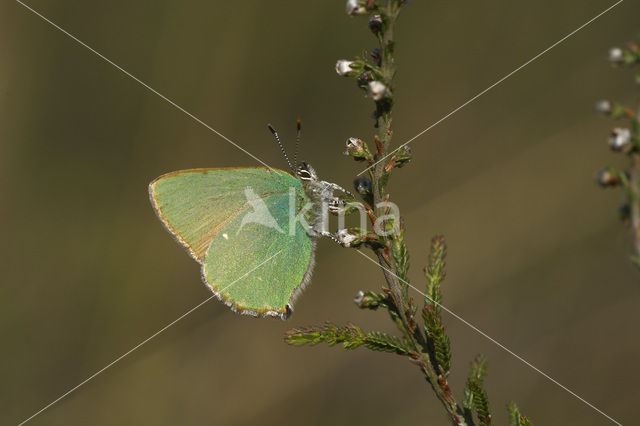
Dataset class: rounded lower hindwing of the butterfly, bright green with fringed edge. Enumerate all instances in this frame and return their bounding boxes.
[202,194,313,316]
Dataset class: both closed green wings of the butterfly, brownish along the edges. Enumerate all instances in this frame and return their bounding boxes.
[149,168,315,319]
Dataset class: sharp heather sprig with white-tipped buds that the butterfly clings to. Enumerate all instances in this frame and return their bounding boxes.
[285,0,528,426]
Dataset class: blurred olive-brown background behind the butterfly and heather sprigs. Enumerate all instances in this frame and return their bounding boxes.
[0,0,640,425]
